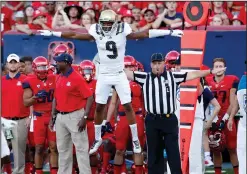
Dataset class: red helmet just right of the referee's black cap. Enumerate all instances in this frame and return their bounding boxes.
[165,50,180,70]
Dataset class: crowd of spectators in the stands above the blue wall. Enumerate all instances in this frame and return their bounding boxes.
[1,1,246,34]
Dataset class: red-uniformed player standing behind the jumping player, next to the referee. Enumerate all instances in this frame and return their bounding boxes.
[106,56,145,174]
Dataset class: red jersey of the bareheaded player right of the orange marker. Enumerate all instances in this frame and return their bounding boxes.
[206,75,239,116]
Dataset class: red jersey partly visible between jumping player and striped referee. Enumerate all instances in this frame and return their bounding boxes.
[118,81,143,112]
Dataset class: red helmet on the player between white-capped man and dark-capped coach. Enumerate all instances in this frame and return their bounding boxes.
[32,56,49,79]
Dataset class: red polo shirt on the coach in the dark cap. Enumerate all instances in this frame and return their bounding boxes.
[55,68,93,112]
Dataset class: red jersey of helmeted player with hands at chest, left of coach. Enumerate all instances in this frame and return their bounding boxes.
[23,75,56,112]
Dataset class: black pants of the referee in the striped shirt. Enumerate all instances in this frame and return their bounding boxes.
[145,114,182,174]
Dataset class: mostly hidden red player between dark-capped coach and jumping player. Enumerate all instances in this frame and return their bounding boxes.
[80,60,99,174]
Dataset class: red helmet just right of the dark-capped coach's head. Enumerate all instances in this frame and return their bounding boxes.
[80,60,95,81]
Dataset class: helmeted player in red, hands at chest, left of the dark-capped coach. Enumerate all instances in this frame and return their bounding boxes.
[22,56,58,174]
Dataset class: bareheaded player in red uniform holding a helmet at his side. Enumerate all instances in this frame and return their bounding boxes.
[206,58,239,174]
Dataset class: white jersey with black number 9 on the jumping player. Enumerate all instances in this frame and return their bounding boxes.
[89,23,132,74]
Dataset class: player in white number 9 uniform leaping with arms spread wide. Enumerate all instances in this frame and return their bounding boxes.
[39,10,183,154]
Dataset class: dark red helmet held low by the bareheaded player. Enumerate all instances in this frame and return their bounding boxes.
[209,130,226,152]
